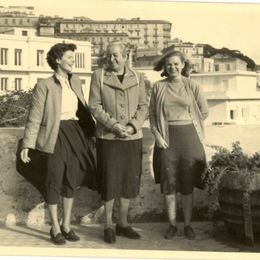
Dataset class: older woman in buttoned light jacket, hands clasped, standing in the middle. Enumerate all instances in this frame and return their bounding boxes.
[89,42,148,243]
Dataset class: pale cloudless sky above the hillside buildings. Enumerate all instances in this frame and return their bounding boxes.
[0,0,260,64]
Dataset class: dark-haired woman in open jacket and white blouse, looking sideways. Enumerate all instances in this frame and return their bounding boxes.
[20,43,96,245]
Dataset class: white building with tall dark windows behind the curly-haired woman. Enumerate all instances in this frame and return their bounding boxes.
[0,34,91,97]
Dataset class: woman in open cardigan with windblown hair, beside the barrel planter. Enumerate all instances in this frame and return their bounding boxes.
[149,51,208,239]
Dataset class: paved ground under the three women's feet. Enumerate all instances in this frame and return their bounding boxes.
[0,222,260,259]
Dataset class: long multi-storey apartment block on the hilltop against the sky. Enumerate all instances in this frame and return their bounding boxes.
[55,18,172,53]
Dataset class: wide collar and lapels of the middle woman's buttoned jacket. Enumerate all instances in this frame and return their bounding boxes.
[103,66,138,90]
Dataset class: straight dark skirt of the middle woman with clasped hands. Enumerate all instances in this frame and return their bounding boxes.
[97,139,142,201]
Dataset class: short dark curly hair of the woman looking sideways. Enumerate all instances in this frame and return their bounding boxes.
[46,43,77,71]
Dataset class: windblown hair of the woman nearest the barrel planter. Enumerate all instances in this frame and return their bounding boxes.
[153,50,190,77]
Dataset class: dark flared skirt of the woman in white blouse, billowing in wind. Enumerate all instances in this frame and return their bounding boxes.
[17,120,97,204]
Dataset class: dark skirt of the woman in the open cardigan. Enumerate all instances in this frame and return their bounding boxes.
[154,124,206,195]
